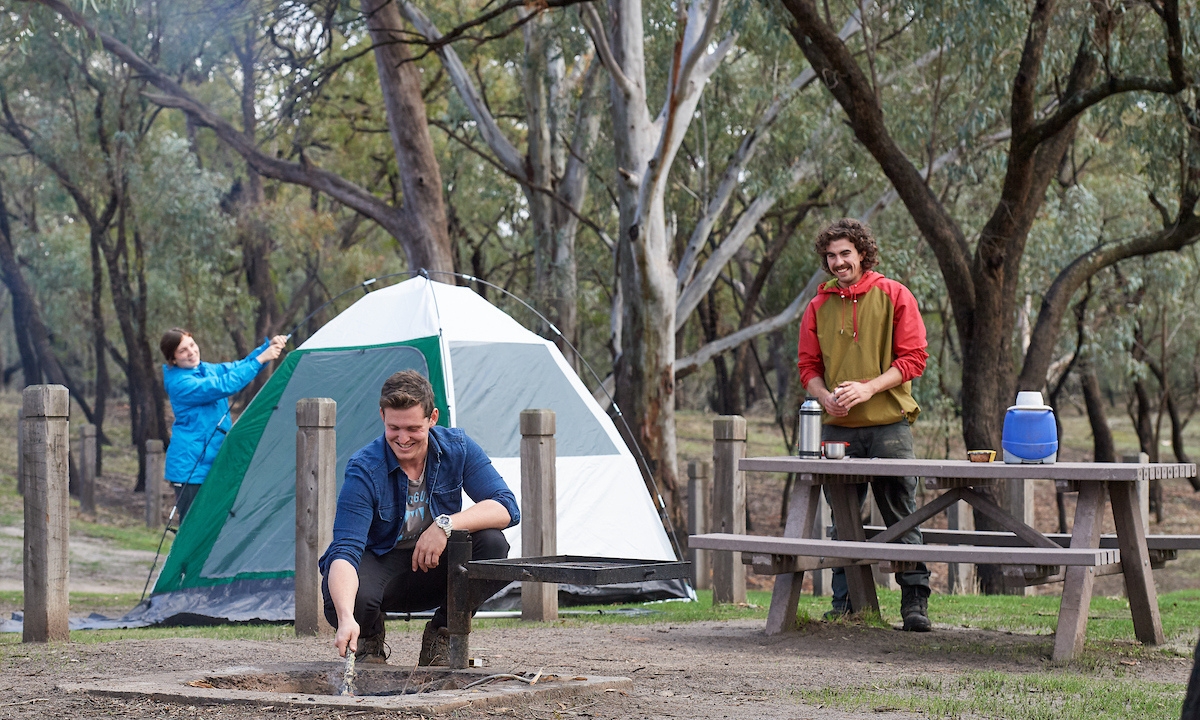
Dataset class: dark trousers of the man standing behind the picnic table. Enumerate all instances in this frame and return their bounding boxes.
[821,420,929,610]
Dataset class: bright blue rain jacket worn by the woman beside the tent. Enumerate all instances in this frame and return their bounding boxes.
[162,341,270,485]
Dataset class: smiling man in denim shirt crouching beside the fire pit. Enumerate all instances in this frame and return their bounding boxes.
[320,370,521,665]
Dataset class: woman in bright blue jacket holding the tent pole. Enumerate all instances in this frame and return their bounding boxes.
[158,328,288,522]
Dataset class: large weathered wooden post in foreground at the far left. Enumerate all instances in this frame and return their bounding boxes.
[20,385,71,642]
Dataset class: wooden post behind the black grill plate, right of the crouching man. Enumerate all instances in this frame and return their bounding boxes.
[521,410,558,622]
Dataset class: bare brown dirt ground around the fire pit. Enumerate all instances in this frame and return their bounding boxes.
[0,620,1190,720]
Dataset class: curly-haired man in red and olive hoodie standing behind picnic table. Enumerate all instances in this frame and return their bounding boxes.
[797,218,930,632]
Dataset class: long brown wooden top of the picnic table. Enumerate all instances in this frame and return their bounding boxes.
[738,456,1196,482]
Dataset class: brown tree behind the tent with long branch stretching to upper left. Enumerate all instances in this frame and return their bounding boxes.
[23,0,454,271]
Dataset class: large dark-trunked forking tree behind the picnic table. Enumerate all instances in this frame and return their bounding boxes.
[784,0,1200,446]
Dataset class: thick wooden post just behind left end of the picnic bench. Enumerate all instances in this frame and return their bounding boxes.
[709,415,746,605]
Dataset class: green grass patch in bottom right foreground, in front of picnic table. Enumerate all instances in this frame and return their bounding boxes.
[794,671,1184,720]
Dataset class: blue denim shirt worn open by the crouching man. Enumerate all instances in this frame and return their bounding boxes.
[320,426,521,575]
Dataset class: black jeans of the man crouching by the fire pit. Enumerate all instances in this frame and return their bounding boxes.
[320,529,509,637]
